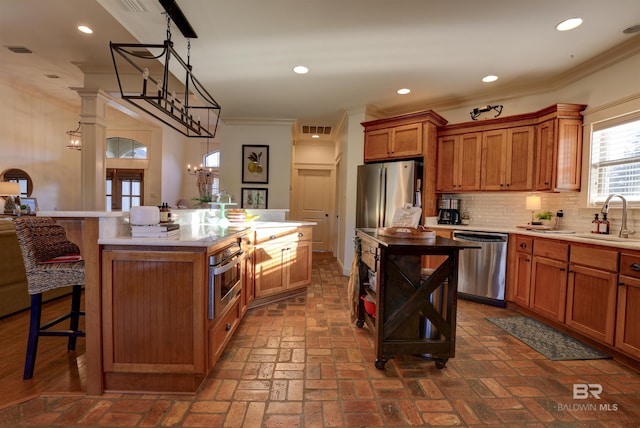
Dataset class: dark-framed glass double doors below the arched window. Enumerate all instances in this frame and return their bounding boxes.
[106,169,144,211]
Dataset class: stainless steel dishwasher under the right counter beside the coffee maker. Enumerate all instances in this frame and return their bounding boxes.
[453,230,509,307]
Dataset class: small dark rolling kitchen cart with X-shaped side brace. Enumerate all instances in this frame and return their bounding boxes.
[356,229,477,369]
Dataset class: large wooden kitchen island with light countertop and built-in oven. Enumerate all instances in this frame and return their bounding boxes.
[38,210,312,394]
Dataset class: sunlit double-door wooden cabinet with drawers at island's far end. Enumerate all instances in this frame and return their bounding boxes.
[254,226,312,301]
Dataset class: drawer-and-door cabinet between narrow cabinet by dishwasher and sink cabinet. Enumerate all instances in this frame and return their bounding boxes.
[529,239,569,322]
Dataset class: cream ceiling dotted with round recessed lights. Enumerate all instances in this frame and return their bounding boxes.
[0,0,640,130]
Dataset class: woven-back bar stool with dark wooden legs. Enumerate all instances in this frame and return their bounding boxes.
[14,217,85,379]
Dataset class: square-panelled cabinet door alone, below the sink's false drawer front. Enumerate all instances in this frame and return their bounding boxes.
[565,264,617,345]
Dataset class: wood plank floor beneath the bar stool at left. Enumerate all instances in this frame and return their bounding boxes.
[0,297,86,409]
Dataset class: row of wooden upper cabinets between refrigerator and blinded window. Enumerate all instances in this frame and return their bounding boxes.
[436,104,586,192]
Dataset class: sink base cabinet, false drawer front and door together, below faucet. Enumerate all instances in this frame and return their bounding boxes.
[565,245,618,345]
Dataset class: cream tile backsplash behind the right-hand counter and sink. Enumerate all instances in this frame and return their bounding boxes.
[443,192,640,238]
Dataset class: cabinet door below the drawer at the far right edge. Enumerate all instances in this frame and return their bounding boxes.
[615,275,640,358]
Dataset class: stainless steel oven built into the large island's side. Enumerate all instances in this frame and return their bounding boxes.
[208,242,244,320]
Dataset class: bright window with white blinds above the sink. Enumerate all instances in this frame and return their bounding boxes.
[589,113,640,205]
